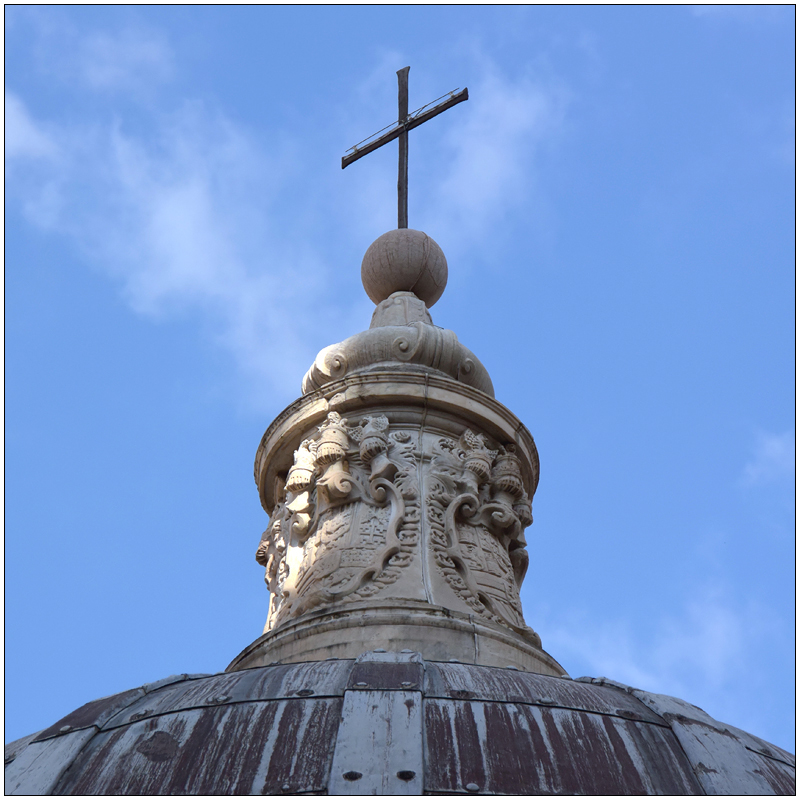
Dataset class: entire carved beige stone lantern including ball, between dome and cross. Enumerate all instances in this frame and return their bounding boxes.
[228,229,564,676]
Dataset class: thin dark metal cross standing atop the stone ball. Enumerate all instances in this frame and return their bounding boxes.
[342,67,469,228]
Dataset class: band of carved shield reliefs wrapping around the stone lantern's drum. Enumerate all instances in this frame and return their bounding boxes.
[256,412,538,643]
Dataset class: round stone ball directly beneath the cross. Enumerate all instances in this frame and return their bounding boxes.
[361,228,447,308]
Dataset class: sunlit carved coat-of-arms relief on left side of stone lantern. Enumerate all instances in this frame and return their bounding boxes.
[256,412,420,630]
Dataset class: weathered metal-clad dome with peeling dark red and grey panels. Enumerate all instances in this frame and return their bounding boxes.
[6,651,795,795]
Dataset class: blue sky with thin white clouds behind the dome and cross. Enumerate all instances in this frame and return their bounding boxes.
[5,6,795,750]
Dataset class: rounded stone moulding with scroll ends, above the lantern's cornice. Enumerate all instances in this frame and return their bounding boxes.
[302,321,494,397]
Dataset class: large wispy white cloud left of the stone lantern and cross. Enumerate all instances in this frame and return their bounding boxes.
[4,96,324,406]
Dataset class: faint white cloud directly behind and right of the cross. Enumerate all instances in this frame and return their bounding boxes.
[339,50,569,262]
